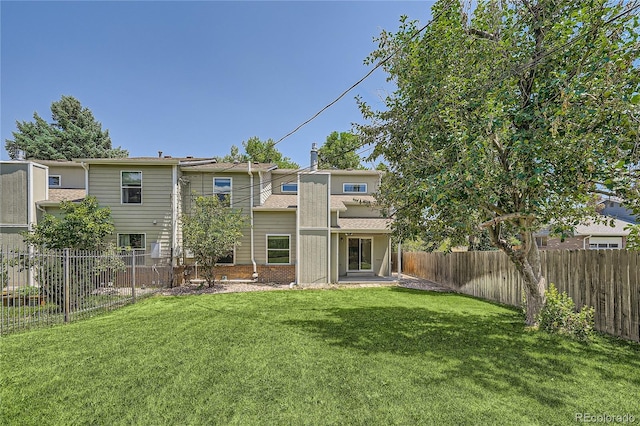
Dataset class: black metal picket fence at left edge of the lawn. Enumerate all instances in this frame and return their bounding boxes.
[0,247,173,335]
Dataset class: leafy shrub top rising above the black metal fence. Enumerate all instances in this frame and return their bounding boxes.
[23,196,114,250]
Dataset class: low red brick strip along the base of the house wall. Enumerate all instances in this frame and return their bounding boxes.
[175,265,296,285]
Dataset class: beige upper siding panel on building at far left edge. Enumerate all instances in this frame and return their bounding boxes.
[0,163,29,225]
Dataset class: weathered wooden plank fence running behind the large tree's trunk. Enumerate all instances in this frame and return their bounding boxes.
[402,250,640,341]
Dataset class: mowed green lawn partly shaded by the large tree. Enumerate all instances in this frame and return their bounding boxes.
[0,288,640,425]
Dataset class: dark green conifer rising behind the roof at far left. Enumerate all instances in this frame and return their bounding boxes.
[5,96,129,160]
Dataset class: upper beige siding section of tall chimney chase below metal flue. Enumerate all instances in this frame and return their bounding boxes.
[298,173,330,228]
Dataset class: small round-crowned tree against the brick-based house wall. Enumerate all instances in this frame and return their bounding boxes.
[182,196,247,286]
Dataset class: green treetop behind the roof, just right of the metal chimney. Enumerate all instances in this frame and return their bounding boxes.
[318,132,365,169]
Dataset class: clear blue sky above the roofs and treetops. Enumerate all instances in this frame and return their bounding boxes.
[0,0,433,166]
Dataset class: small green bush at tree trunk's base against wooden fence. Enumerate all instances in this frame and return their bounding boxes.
[538,283,594,340]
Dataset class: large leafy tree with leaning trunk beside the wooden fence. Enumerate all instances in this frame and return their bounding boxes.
[359,0,640,324]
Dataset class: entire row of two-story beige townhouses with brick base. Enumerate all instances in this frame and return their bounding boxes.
[2,149,391,284]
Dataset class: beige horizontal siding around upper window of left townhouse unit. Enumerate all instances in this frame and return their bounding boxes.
[89,164,173,264]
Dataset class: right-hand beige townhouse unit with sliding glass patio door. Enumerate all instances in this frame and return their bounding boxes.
[179,146,391,284]
